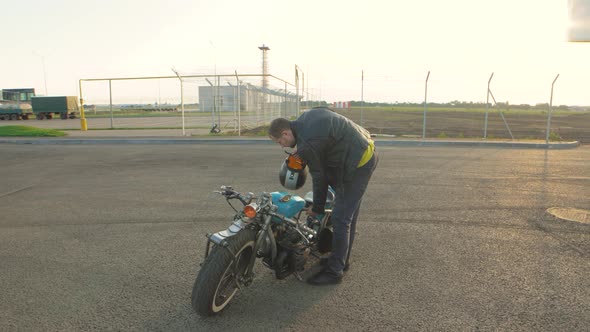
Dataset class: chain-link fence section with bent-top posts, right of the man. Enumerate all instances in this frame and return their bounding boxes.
[335,73,590,142]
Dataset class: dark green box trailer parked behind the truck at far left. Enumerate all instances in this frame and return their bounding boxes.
[31,96,80,120]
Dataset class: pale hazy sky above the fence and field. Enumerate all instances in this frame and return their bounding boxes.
[0,0,590,105]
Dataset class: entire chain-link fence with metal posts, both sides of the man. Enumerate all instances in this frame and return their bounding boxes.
[80,73,590,142]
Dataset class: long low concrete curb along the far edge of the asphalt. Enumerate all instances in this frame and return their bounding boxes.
[0,137,580,149]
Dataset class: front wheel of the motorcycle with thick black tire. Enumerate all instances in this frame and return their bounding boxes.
[191,229,256,317]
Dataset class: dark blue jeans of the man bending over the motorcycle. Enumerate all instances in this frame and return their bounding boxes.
[327,152,379,274]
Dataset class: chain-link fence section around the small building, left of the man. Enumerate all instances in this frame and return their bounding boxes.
[80,73,300,132]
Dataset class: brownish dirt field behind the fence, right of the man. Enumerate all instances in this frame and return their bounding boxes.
[336,109,590,143]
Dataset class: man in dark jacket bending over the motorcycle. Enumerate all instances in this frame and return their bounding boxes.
[268,107,377,285]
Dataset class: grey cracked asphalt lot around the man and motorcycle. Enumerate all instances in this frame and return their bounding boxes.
[0,144,590,331]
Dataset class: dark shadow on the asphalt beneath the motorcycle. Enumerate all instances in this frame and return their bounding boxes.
[142,258,338,331]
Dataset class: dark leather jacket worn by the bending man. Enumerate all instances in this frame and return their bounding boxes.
[291,107,371,214]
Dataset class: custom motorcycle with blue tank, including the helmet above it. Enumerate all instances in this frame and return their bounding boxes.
[191,154,335,316]
